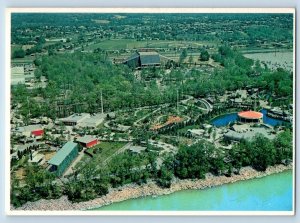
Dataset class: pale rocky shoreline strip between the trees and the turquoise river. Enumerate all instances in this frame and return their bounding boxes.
[11,164,293,211]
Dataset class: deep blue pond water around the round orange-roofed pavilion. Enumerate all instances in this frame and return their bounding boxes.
[212,109,286,127]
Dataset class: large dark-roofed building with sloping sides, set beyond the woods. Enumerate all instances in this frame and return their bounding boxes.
[123,51,169,68]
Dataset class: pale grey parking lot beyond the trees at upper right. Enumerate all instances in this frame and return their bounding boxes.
[244,51,293,70]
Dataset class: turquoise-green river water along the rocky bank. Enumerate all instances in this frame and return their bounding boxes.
[94,171,293,211]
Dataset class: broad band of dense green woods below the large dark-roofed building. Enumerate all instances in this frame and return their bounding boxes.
[12,46,293,118]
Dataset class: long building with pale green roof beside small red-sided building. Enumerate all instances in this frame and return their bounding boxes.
[48,141,78,176]
